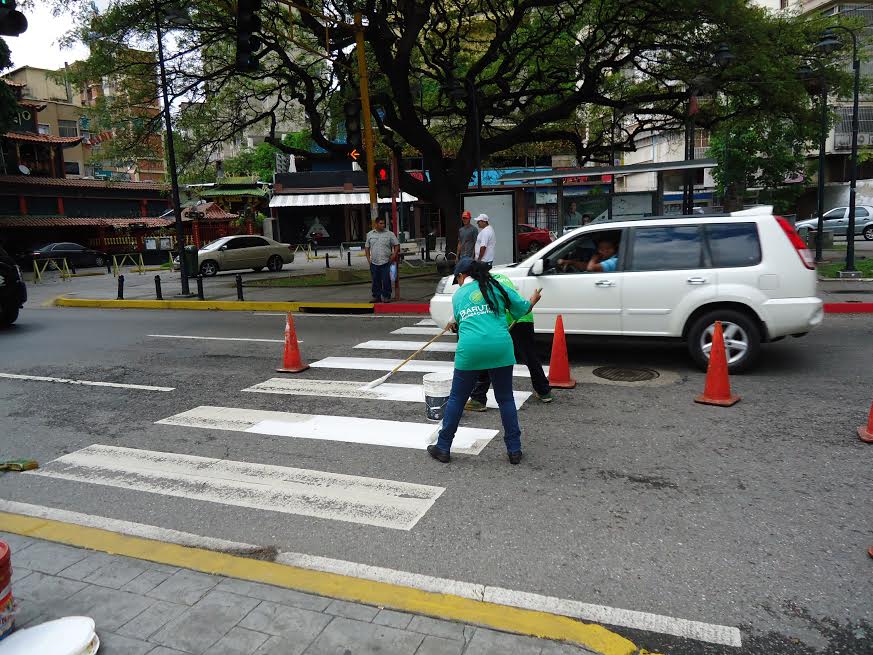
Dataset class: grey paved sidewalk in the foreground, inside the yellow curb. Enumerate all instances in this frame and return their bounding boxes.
[0,533,594,655]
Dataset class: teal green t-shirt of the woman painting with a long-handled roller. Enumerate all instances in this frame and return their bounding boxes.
[452,281,531,371]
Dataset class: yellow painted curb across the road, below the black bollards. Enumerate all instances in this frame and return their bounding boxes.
[54,298,373,312]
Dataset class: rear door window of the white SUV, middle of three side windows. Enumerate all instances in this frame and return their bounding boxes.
[630,225,703,271]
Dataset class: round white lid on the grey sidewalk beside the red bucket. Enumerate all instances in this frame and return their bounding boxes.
[0,616,100,655]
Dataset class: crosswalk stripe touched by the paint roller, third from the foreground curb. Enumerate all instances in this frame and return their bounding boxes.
[243,378,531,408]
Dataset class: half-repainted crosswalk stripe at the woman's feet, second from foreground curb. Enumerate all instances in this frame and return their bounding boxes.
[157,404,497,455]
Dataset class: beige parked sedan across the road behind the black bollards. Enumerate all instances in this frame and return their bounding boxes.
[174,235,294,276]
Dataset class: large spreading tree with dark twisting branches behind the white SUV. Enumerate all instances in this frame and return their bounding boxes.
[63,0,844,249]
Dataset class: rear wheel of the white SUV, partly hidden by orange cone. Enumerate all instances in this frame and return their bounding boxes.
[687,309,761,373]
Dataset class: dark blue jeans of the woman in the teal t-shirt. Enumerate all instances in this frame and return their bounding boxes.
[436,366,521,453]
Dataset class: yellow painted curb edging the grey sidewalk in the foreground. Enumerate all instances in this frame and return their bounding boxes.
[0,512,638,655]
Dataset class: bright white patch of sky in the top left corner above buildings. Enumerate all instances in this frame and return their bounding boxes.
[3,0,93,70]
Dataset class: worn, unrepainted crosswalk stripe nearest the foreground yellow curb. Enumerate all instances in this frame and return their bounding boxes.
[31,444,445,530]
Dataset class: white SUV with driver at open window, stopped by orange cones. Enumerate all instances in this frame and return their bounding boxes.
[430,207,823,372]
